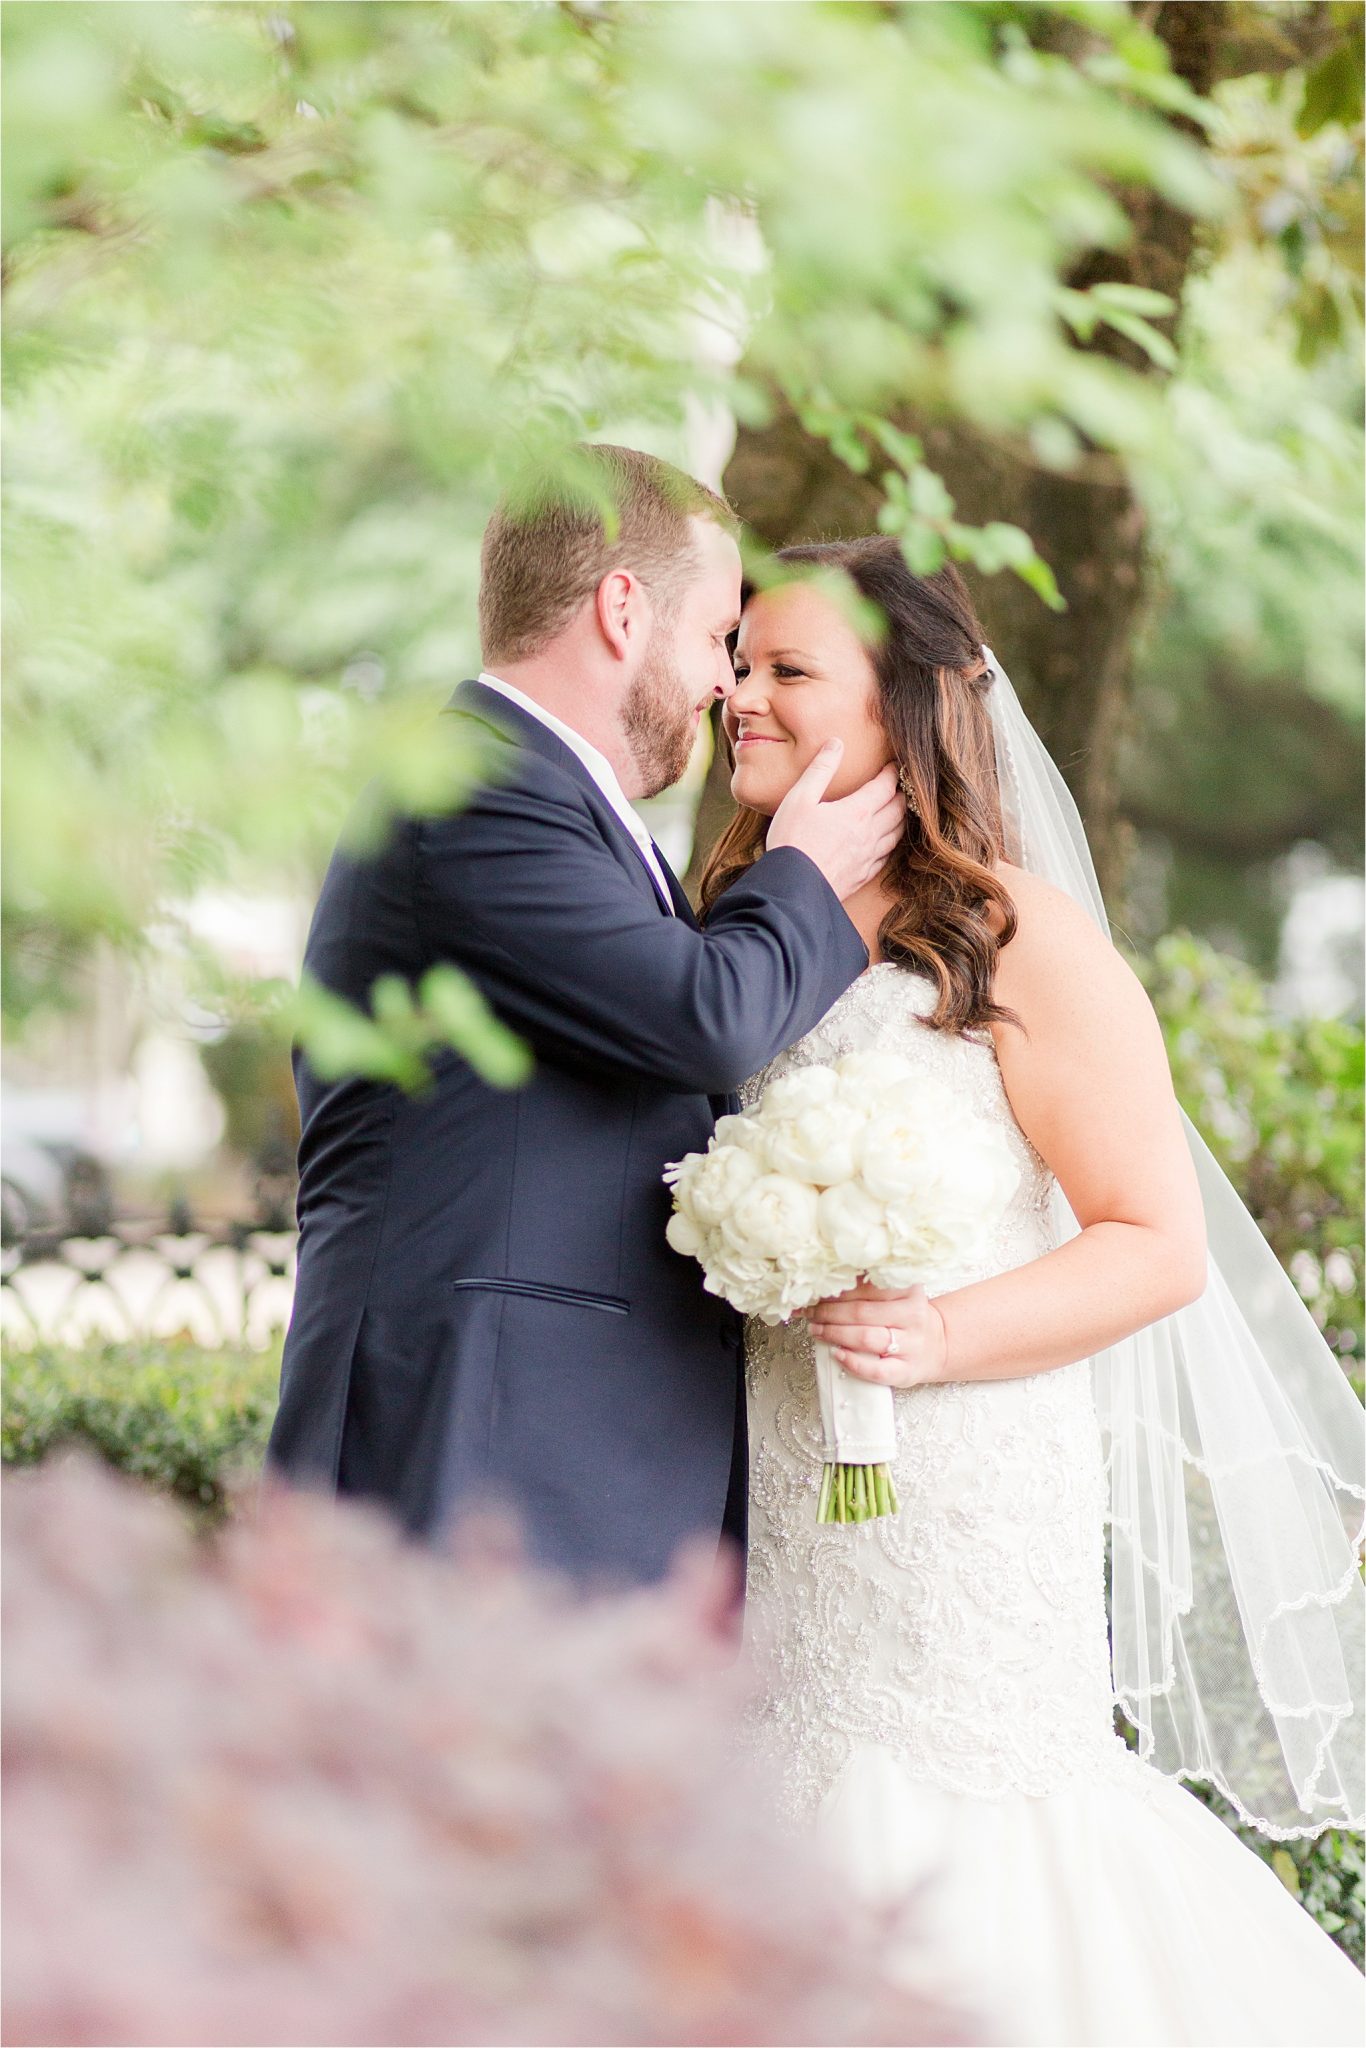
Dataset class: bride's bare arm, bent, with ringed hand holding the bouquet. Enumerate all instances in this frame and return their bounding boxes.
[811,868,1204,1386]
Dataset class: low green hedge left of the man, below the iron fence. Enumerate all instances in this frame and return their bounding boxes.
[2,1339,281,1520]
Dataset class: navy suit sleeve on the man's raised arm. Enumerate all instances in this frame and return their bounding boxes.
[414,772,868,1094]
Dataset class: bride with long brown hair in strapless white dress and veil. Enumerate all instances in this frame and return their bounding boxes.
[702,539,1362,2048]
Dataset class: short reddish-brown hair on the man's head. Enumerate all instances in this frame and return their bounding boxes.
[479,442,739,666]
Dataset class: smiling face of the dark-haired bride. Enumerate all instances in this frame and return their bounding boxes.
[721,584,891,817]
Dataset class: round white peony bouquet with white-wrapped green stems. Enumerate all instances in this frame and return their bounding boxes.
[664,1051,1020,1522]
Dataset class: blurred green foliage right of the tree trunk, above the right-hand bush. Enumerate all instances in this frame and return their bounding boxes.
[1122,58,1364,969]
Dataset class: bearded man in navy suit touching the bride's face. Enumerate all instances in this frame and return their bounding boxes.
[268,444,903,1585]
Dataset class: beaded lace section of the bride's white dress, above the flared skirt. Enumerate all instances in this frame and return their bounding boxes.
[741,965,1133,1812]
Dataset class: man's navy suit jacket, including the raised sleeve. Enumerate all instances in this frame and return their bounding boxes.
[268,682,866,1583]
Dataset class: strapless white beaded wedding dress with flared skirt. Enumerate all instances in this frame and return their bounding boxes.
[743,965,1366,2048]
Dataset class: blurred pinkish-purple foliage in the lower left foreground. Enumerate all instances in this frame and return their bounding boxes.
[4,1452,967,2048]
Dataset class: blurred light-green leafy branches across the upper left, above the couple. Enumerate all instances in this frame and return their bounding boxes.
[2,0,1225,1065]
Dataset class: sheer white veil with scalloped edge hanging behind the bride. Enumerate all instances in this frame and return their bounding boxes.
[983,647,1366,1837]
